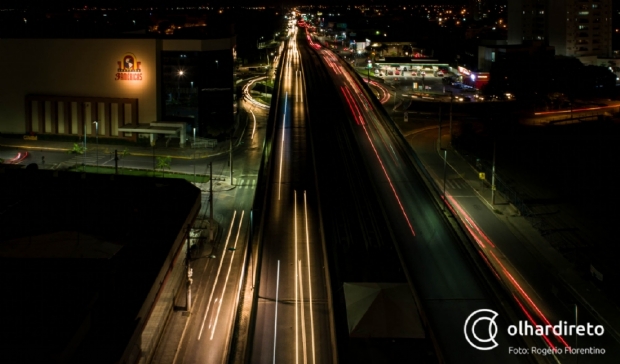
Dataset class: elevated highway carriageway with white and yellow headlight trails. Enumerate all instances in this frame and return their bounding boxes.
[251,26,334,364]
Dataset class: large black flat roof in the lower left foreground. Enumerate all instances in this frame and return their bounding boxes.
[0,166,200,364]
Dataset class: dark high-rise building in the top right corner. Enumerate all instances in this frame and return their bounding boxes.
[508,0,612,57]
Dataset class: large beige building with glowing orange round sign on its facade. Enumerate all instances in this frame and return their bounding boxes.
[0,34,236,144]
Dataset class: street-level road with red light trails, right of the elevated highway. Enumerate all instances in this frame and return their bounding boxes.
[364,60,620,363]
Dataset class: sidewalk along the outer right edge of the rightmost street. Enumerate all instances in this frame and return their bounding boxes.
[408,131,620,341]
